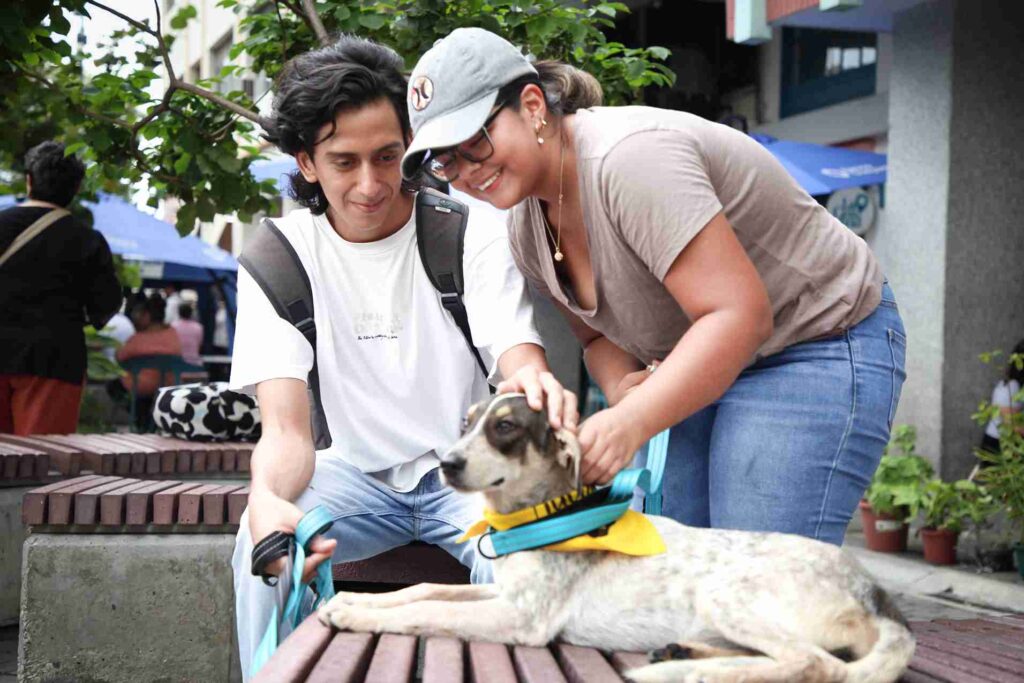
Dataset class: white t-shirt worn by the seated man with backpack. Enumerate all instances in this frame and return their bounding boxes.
[230,197,543,490]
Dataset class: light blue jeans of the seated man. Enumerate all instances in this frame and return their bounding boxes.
[231,458,492,680]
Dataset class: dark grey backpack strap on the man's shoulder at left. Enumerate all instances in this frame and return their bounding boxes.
[239,218,332,451]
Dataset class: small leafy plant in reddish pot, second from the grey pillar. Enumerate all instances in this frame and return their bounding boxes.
[920,479,992,564]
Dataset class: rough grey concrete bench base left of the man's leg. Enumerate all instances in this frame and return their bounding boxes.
[18,533,241,683]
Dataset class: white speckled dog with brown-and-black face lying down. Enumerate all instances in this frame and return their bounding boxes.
[319,394,914,683]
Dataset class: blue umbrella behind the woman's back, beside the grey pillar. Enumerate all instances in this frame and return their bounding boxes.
[751,133,886,197]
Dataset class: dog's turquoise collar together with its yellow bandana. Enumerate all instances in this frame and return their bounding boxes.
[459,470,666,557]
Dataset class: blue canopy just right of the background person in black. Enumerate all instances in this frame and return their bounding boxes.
[0,194,239,283]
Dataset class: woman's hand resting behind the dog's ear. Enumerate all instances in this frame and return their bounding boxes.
[580,405,647,484]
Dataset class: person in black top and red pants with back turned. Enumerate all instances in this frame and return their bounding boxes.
[0,141,121,434]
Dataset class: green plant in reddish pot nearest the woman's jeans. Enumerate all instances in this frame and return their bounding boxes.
[860,425,933,553]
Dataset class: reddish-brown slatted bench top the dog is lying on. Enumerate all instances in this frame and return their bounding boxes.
[254,615,1024,683]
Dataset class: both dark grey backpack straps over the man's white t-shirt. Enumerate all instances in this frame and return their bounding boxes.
[239,187,487,451]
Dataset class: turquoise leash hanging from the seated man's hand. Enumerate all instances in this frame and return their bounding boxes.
[250,505,334,676]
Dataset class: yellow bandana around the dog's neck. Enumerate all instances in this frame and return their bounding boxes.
[459,487,665,557]
